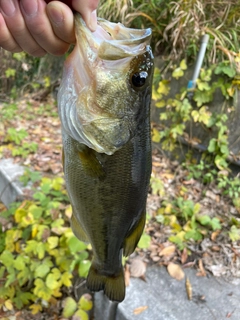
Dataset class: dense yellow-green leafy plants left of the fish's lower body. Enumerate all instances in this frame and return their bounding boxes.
[0,173,90,319]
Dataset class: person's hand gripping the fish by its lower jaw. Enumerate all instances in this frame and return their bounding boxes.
[0,0,99,57]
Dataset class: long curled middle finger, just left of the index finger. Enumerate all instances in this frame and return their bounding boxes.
[20,0,69,55]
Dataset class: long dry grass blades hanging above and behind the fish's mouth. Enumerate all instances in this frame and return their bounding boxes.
[98,0,240,62]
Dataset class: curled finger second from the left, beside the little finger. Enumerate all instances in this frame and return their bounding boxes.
[0,0,46,56]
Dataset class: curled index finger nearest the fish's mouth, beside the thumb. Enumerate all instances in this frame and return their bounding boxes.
[46,1,75,43]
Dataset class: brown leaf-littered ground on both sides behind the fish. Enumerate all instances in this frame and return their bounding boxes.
[0,97,240,320]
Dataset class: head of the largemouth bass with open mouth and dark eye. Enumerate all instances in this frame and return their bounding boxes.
[59,14,153,154]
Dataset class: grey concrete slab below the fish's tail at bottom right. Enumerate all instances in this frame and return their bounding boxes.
[95,267,240,320]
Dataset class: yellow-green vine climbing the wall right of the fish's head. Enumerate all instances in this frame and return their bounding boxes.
[152,55,237,170]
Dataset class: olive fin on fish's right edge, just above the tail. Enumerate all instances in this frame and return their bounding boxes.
[123,213,146,257]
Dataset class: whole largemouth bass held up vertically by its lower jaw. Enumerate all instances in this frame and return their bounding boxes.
[58,14,154,302]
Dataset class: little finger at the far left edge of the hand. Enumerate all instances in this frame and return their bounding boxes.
[0,13,22,52]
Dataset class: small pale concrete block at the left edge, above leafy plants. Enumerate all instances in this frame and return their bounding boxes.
[0,159,24,207]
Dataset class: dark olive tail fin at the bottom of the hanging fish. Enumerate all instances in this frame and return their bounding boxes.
[87,261,125,302]
